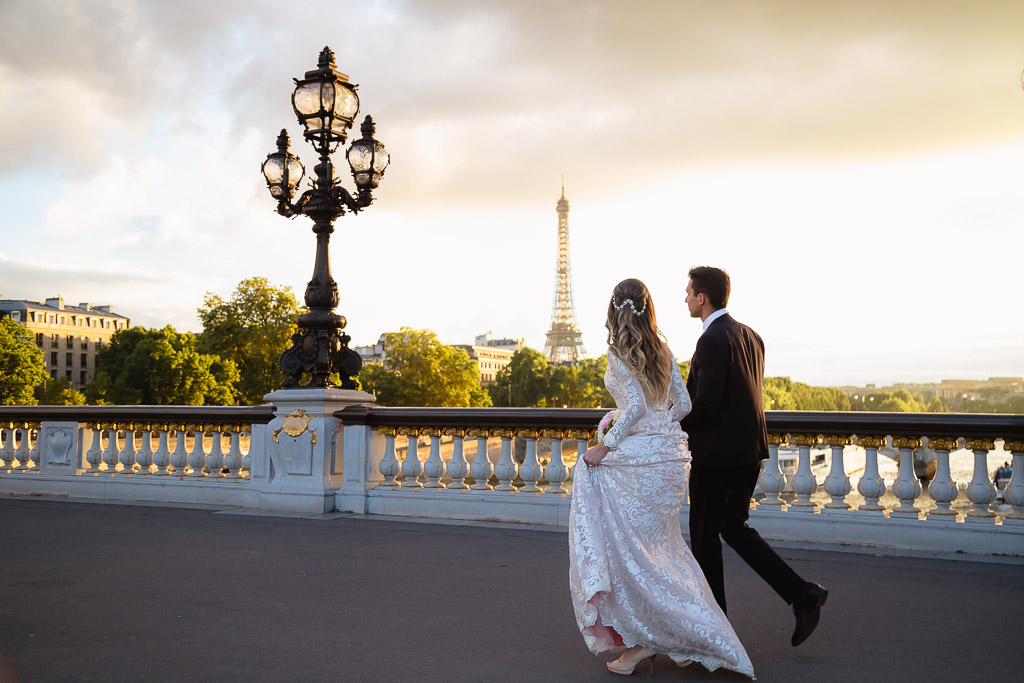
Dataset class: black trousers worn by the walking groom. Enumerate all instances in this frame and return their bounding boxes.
[690,464,805,611]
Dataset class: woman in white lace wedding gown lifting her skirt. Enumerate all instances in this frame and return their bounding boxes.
[569,280,754,678]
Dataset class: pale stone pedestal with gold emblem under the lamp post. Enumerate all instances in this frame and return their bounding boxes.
[260,389,376,513]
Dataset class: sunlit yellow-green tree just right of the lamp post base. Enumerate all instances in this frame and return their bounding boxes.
[359,328,490,408]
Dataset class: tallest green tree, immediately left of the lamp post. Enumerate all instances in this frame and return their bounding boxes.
[197,278,303,404]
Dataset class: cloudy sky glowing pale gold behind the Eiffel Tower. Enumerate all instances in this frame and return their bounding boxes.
[0,0,1024,384]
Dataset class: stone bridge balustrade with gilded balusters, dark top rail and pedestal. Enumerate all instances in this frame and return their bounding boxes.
[0,401,1024,555]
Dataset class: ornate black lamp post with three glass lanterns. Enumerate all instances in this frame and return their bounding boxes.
[263,47,388,389]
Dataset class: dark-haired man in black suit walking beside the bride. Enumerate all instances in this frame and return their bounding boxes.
[680,266,828,646]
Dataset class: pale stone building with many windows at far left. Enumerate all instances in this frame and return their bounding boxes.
[0,297,131,390]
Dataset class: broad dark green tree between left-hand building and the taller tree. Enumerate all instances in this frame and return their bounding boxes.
[85,326,240,405]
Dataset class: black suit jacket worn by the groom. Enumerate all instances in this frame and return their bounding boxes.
[680,313,768,469]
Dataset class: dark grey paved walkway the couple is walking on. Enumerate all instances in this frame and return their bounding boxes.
[0,499,1024,683]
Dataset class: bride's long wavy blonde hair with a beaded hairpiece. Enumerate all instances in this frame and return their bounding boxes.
[604,278,672,400]
